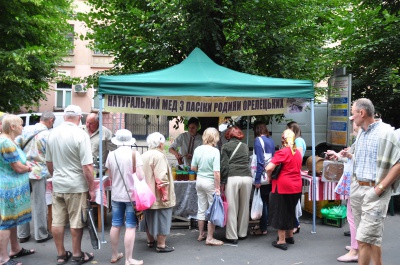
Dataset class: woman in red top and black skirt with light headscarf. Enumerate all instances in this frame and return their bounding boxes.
[267,129,302,250]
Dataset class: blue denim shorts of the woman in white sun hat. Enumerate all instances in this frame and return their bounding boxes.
[111,201,137,228]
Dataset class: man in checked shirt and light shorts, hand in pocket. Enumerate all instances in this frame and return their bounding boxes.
[342,98,400,265]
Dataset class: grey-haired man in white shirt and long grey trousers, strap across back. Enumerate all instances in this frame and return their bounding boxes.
[15,112,55,243]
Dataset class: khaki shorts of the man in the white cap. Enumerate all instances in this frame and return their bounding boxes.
[52,192,88,229]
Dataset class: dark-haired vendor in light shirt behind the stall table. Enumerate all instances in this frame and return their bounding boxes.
[169,117,203,167]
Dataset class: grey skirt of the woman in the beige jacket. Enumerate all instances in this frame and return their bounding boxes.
[144,208,172,237]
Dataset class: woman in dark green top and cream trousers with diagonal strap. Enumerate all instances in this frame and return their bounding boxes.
[221,126,253,244]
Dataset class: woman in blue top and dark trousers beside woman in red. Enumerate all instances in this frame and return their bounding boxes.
[253,121,275,236]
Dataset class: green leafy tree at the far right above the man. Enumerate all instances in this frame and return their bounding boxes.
[332,0,400,128]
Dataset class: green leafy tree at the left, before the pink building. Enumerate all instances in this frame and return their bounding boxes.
[0,0,73,112]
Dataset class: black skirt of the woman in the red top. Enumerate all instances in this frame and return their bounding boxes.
[269,192,301,230]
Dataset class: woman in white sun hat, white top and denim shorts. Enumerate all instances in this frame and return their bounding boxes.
[105,129,144,265]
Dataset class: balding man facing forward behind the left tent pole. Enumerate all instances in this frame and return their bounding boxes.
[82,113,117,168]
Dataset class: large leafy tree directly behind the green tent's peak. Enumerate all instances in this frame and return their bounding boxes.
[78,0,339,85]
